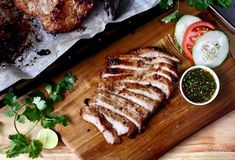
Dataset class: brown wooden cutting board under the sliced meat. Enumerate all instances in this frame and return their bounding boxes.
[55,5,235,160]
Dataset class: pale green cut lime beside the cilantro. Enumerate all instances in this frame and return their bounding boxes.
[37,129,58,149]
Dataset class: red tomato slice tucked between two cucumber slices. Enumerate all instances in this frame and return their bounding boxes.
[182,21,215,62]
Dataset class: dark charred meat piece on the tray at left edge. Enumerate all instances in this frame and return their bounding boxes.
[0,1,31,62]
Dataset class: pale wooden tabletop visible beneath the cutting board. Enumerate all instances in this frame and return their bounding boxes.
[0,109,235,160]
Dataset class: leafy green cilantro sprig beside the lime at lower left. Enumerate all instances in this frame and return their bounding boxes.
[0,73,76,158]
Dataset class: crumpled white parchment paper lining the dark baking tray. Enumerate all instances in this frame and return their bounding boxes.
[0,0,160,91]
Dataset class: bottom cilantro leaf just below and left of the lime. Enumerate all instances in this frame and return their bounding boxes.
[28,139,43,158]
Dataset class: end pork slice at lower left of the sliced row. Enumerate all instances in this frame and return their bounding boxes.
[80,107,121,144]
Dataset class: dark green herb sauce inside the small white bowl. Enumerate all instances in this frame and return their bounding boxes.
[182,68,216,103]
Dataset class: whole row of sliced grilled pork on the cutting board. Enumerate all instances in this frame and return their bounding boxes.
[81,48,179,144]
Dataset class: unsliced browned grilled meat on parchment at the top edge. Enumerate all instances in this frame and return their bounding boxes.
[14,0,94,32]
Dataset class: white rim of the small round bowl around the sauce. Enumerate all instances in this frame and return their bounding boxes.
[180,66,220,106]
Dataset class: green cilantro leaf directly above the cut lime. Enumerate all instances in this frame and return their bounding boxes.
[41,114,69,129]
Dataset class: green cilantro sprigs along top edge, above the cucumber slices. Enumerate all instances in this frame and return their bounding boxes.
[159,0,233,23]
